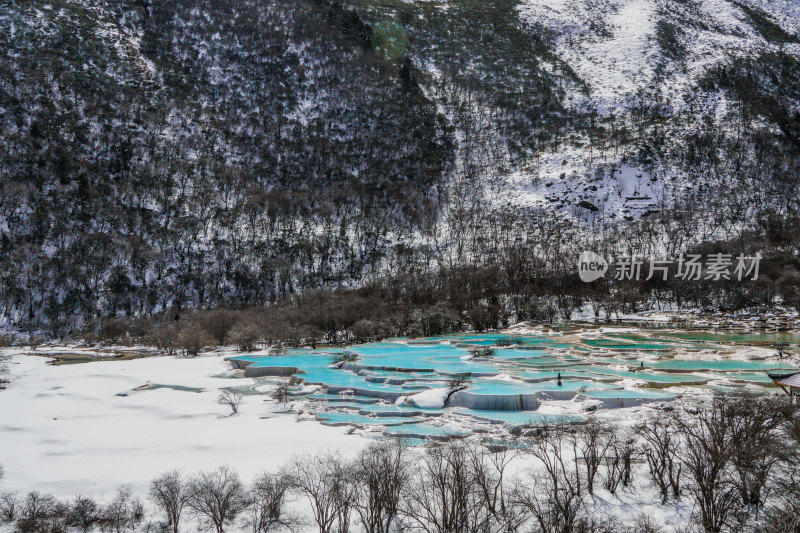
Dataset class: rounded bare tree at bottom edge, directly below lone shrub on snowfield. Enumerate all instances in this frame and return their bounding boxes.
[186,466,247,533]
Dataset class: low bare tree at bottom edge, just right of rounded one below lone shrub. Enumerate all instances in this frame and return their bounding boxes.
[244,472,302,533]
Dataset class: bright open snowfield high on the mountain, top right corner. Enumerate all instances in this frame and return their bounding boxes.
[518,0,800,110]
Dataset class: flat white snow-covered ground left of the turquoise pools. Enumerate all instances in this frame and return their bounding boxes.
[0,354,369,497]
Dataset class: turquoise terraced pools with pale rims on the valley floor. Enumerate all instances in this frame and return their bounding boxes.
[231,326,800,439]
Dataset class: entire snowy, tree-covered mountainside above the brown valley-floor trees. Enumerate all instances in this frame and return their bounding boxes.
[0,0,800,332]
